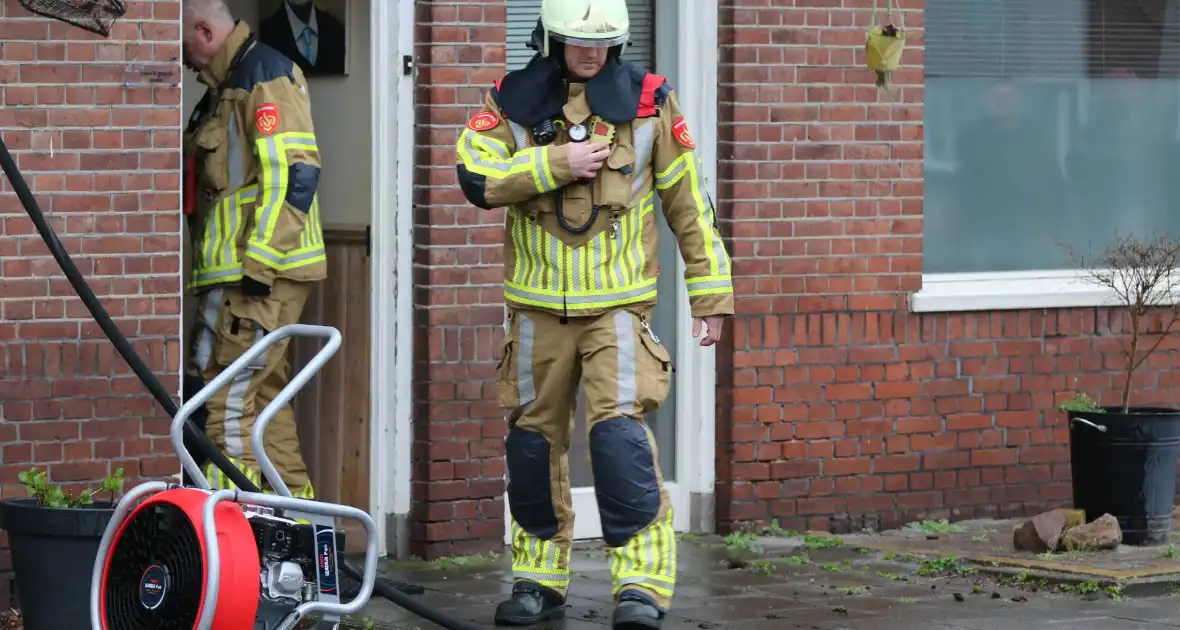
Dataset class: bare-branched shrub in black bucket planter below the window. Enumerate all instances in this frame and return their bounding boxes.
[1061,236,1180,545]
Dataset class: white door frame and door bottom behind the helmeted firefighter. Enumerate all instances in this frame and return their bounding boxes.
[504,0,719,544]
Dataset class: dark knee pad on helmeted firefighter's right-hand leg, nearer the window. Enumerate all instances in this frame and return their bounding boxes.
[590,418,660,546]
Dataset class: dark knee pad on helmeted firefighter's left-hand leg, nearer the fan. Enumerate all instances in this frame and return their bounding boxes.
[506,427,557,540]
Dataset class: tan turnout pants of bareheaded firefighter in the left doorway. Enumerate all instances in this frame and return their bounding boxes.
[186,278,315,498]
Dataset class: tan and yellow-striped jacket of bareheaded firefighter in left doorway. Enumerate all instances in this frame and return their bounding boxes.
[184,22,327,291]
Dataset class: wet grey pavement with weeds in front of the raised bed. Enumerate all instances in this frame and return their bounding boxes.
[344,532,1180,630]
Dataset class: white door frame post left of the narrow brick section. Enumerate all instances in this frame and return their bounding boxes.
[369,0,417,557]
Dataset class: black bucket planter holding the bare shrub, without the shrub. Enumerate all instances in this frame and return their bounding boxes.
[1069,407,1180,545]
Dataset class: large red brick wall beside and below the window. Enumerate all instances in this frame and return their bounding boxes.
[716,0,1180,531]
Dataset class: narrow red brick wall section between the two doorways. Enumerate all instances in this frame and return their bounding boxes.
[411,0,507,557]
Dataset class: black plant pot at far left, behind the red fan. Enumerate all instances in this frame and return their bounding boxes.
[0,499,114,630]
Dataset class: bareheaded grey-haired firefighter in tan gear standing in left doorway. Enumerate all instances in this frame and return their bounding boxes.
[183,0,327,498]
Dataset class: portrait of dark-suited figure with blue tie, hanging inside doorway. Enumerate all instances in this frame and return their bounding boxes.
[258,0,348,77]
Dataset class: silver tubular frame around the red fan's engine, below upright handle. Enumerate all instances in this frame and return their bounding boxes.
[193,490,378,630]
